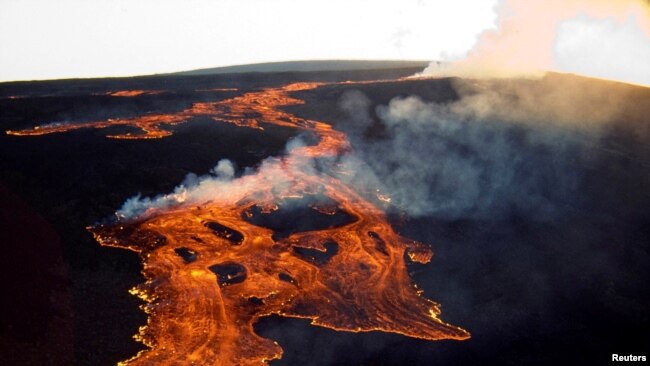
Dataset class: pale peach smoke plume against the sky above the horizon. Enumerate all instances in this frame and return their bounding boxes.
[422,0,650,85]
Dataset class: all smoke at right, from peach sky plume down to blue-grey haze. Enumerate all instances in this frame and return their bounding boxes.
[394,0,650,218]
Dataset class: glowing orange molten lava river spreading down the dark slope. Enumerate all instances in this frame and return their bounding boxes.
[7,83,469,365]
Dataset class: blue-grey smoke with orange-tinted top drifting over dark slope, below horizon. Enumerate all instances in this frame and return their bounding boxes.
[339,67,650,220]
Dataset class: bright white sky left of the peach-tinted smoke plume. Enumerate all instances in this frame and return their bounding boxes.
[0,0,496,81]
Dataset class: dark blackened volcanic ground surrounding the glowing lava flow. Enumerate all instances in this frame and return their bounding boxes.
[0,64,650,365]
